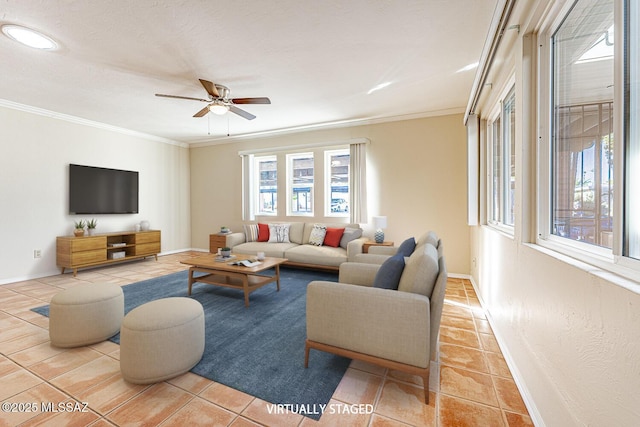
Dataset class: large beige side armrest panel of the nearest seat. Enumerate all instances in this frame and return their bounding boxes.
[307,281,430,368]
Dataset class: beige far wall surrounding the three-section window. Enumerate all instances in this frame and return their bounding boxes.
[191,115,469,274]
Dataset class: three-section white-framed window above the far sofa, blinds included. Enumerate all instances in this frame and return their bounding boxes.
[238,138,369,223]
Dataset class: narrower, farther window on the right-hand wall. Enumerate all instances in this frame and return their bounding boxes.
[489,87,516,227]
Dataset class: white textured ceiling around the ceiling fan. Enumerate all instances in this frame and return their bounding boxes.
[0,0,496,142]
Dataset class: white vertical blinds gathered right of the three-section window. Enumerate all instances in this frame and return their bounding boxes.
[349,142,368,224]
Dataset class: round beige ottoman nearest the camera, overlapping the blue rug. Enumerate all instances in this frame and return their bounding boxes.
[120,297,204,384]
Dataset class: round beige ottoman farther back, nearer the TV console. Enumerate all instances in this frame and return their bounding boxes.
[49,283,124,347]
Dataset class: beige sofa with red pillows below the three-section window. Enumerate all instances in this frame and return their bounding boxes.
[226,222,367,270]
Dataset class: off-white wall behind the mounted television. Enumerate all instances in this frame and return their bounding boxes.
[0,107,191,284]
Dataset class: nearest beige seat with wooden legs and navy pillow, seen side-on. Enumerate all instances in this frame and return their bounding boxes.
[305,234,447,403]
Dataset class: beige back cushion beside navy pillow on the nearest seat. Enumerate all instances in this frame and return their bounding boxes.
[398,243,438,297]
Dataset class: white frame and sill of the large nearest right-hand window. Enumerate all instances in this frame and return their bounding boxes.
[535,0,640,280]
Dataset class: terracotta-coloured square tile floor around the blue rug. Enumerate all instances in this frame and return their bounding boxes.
[0,252,533,427]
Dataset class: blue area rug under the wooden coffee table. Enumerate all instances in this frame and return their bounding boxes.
[33,268,350,419]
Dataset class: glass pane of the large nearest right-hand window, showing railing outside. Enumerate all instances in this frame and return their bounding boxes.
[548,0,616,250]
